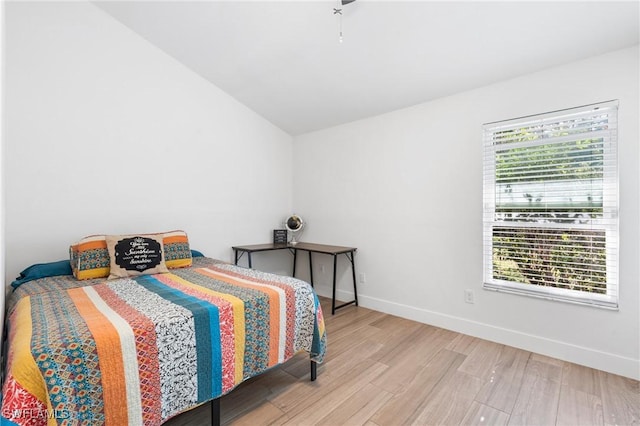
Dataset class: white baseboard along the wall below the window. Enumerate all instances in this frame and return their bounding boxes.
[316,289,640,380]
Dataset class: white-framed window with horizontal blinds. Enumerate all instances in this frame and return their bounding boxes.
[484,101,618,309]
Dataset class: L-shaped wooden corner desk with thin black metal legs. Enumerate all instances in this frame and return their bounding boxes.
[232,242,358,315]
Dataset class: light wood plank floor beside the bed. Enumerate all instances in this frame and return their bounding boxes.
[167,299,640,426]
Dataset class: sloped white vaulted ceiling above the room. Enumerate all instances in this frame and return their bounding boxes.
[93,0,640,135]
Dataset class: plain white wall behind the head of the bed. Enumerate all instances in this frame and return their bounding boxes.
[4,2,292,284]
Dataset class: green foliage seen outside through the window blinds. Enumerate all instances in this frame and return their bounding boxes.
[493,122,607,294]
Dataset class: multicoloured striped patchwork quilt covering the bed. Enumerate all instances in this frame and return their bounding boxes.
[2,258,325,426]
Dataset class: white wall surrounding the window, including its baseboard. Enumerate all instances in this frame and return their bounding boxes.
[293,47,640,379]
